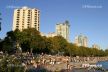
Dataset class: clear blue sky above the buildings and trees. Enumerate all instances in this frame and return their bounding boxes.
[0,0,108,49]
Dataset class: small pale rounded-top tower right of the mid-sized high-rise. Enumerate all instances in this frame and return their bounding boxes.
[75,35,88,47]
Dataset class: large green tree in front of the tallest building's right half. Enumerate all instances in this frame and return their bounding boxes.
[22,28,45,53]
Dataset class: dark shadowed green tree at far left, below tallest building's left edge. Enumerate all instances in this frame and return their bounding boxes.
[3,30,22,53]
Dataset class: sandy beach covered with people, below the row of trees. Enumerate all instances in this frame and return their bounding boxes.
[1,53,108,72]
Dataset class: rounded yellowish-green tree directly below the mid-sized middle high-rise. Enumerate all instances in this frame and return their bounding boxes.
[50,36,68,54]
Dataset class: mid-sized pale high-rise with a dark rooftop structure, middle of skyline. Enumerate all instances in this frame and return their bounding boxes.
[56,21,70,41]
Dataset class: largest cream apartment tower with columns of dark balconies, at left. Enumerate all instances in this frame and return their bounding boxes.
[12,7,40,31]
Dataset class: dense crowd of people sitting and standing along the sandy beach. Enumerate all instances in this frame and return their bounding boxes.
[0,52,108,71]
